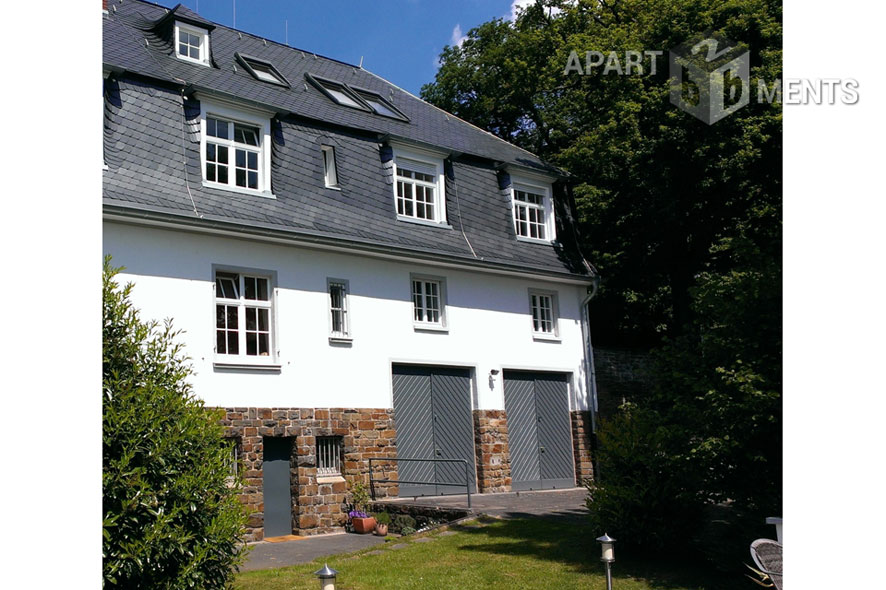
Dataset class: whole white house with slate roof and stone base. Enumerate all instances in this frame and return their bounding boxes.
[103,0,596,540]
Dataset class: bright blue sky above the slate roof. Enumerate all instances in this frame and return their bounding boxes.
[155,0,526,94]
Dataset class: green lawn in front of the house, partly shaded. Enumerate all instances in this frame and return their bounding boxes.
[235,519,744,590]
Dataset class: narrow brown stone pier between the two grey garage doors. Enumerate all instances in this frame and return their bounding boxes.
[474,410,511,493]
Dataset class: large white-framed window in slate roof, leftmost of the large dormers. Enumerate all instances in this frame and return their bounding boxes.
[200,98,273,197]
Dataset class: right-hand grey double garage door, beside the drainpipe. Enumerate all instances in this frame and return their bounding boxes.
[504,371,575,491]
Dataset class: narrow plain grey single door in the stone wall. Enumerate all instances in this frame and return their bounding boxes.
[262,436,292,537]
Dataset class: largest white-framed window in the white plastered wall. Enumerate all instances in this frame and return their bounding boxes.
[213,269,276,364]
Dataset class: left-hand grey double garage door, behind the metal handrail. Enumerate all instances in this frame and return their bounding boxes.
[392,365,476,496]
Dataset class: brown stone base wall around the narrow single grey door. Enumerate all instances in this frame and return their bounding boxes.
[222,408,397,541]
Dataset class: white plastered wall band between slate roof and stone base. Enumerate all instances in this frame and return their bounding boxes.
[103,221,589,410]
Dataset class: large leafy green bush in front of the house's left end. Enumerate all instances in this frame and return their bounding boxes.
[102,258,245,590]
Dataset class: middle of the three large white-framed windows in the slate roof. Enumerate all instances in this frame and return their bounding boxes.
[394,149,446,224]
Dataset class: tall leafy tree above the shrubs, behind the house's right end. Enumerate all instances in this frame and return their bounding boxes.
[422,0,781,347]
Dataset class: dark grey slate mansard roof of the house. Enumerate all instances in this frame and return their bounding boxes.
[103,0,593,278]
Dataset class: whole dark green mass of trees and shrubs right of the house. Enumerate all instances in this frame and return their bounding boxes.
[422,0,782,550]
